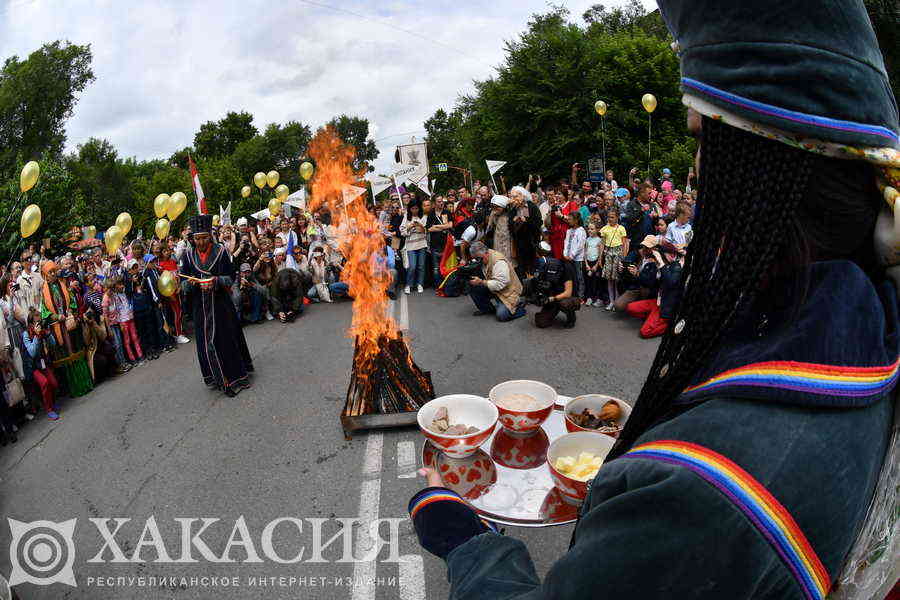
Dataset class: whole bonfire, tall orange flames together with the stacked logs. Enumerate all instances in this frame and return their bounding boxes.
[309,127,434,438]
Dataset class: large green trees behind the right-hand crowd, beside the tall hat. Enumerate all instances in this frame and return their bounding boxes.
[425,2,694,188]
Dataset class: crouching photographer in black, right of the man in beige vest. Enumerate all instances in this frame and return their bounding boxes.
[525,242,581,329]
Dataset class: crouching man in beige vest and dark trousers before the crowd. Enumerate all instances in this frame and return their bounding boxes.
[469,242,525,323]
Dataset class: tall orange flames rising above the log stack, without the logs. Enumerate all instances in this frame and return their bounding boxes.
[309,126,400,367]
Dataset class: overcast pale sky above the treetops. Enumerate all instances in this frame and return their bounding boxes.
[0,0,656,173]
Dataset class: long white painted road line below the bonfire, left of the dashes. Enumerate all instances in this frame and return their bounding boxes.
[350,432,384,600]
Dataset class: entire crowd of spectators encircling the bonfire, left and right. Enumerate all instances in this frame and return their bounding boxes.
[0,164,694,444]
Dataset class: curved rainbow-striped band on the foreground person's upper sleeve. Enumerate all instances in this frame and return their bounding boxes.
[624,440,831,600]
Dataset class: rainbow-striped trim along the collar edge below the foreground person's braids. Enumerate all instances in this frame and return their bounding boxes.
[683,359,900,398]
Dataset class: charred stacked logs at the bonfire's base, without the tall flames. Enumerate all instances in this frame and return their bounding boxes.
[341,337,434,435]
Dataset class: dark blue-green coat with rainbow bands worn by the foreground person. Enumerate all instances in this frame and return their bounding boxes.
[410,261,898,600]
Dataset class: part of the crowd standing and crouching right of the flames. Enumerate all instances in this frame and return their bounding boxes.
[379,163,696,338]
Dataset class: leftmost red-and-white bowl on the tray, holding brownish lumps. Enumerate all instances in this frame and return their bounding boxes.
[416,394,498,458]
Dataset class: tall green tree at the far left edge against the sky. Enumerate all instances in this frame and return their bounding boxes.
[0,41,94,177]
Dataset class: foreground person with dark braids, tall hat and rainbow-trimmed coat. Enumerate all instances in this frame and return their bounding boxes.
[409,0,900,600]
